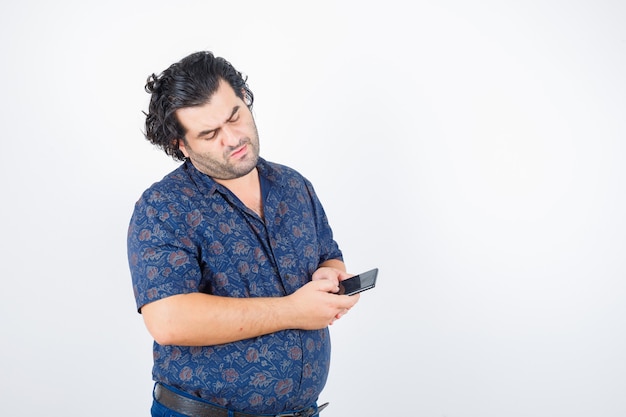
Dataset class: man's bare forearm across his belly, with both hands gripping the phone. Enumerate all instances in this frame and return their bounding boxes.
[141,259,358,346]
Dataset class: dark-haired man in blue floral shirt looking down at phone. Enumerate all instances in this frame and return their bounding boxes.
[128,52,359,417]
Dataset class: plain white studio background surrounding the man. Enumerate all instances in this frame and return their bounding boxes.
[0,0,626,417]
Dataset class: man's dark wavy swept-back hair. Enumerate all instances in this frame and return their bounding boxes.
[144,51,254,161]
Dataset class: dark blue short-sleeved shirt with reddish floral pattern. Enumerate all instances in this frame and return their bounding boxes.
[128,158,342,414]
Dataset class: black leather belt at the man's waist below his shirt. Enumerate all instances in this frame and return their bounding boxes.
[154,384,328,417]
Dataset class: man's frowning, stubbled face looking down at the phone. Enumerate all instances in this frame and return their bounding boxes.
[176,80,259,180]
